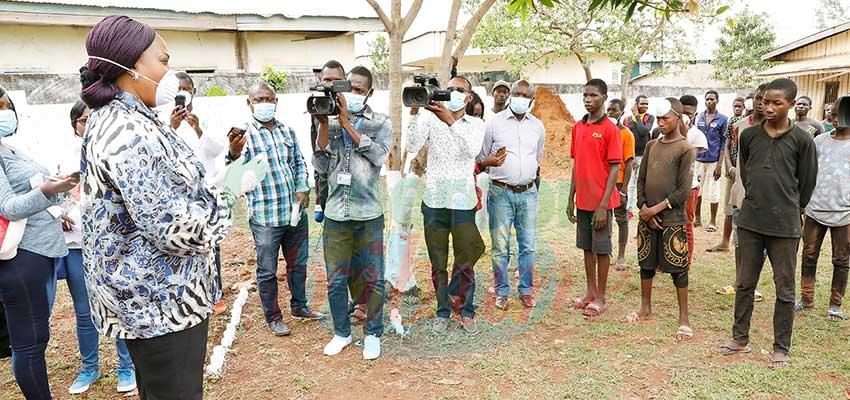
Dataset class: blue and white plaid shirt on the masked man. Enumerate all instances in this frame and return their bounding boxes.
[227,120,310,227]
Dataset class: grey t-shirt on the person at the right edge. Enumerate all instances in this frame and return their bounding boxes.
[806,135,850,226]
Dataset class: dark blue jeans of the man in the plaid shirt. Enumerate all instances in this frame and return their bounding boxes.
[249,212,309,323]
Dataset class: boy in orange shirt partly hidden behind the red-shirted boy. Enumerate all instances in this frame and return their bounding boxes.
[607,99,635,271]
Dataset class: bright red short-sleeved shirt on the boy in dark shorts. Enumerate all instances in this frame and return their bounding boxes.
[570,115,623,211]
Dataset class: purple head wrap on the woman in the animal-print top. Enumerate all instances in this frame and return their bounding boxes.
[80,15,156,109]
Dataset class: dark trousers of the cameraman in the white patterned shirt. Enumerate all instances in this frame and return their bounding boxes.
[422,203,484,318]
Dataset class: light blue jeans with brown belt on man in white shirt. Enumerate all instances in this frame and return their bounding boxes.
[487,185,537,297]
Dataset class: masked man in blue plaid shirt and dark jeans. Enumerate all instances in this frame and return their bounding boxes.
[226,82,324,336]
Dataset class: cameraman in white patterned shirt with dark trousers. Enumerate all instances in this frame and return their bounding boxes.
[408,76,484,335]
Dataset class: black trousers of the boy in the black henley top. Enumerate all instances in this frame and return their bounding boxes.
[732,227,800,354]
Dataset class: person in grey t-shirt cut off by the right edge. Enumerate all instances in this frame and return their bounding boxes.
[797,107,850,320]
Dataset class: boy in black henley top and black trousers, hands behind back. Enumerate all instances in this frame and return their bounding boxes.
[720,78,818,367]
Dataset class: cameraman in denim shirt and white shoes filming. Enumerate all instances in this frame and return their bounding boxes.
[313,61,392,360]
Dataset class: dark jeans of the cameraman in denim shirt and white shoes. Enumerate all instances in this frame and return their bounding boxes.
[322,216,385,337]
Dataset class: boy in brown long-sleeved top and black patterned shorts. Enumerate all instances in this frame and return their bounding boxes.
[624,97,696,341]
